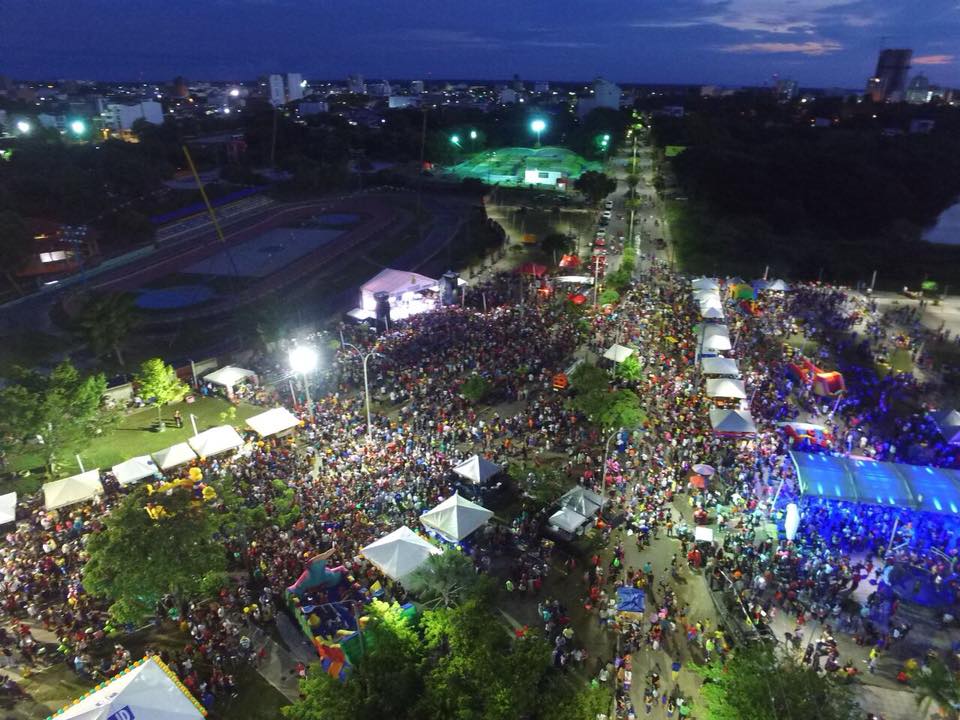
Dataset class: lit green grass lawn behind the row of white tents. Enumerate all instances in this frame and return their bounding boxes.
[0,398,263,494]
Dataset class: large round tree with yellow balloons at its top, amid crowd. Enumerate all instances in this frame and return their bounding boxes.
[83,486,226,623]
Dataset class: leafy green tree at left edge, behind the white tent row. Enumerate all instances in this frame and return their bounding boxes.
[0,360,117,474]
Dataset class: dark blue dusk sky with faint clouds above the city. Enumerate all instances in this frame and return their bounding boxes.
[7,0,960,88]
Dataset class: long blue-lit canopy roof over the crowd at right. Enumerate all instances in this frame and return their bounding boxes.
[790,450,960,515]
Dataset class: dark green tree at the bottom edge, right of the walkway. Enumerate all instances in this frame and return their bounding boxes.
[693,645,863,720]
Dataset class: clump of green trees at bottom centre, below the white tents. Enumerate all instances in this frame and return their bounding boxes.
[284,550,612,720]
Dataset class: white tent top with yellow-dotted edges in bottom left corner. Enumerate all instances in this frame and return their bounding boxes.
[47,655,206,720]
